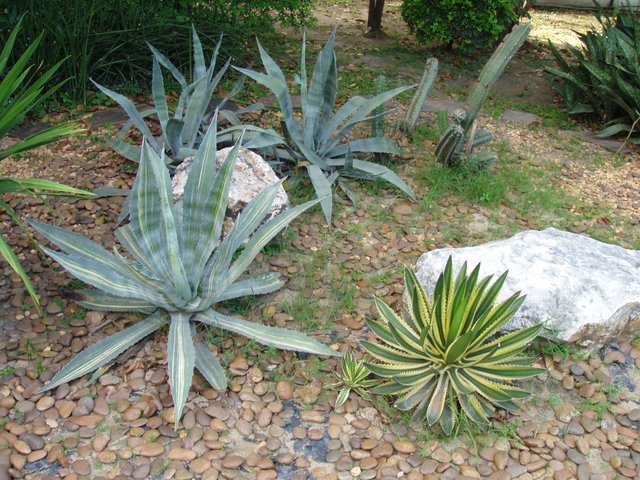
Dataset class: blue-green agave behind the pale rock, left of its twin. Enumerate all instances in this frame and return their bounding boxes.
[96,27,282,169]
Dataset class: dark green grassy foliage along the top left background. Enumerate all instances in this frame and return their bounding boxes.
[0,0,313,101]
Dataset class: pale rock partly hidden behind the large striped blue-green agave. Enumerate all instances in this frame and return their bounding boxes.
[172,147,289,232]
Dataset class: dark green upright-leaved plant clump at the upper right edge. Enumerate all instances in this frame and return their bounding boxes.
[545,7,640,143]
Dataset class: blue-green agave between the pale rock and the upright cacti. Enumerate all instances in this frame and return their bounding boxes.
[236,30,415,225]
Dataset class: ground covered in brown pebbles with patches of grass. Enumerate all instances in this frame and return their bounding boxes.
[0,2,640,480]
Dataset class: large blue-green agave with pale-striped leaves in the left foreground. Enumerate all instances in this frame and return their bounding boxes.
[30,121,336,428]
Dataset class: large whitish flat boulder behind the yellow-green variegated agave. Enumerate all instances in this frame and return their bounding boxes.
[416,228,640,345]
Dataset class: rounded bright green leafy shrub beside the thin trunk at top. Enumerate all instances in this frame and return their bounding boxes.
[402,0,524,52]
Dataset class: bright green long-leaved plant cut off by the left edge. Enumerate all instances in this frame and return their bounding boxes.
[0,18,91,308]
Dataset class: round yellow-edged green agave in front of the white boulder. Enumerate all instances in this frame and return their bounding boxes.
[364,258,543,435]
